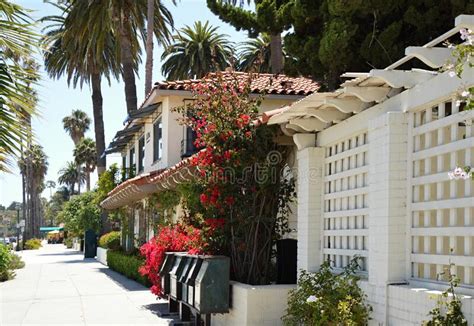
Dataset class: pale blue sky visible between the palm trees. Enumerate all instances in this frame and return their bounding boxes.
[0,0,247,206]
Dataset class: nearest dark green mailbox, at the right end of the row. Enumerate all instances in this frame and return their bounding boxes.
[194,256,230,314]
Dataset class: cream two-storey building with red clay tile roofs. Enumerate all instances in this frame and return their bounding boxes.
[101,71,319,249]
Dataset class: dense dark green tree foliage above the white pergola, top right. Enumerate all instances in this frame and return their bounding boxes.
[282,0,474,89]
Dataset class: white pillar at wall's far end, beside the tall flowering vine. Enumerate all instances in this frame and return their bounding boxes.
[297,147,324,272]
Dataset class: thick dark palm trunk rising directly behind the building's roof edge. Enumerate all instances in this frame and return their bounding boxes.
[120,15,137,114]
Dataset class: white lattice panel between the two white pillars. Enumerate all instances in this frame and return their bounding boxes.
[322,132,369,271]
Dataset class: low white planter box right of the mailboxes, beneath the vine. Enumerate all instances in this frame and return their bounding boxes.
[211,282,296,326]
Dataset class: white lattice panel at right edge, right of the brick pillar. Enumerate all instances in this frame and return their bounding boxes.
[408,99,474,285]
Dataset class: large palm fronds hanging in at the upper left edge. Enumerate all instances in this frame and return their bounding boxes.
[0,0,39,172]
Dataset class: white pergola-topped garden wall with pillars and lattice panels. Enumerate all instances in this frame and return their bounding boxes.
[268,15,474,325]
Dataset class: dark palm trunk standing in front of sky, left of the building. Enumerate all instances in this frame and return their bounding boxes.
[88,73,107,177]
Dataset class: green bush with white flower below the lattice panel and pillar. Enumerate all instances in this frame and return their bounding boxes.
[282,257,372,326]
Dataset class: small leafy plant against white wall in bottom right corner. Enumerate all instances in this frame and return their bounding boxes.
[423,264,467,326]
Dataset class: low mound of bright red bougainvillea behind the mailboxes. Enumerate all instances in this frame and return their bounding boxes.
[139,224,208,296]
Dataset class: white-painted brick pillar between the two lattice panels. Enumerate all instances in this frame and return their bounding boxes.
[368,112,408,322]
